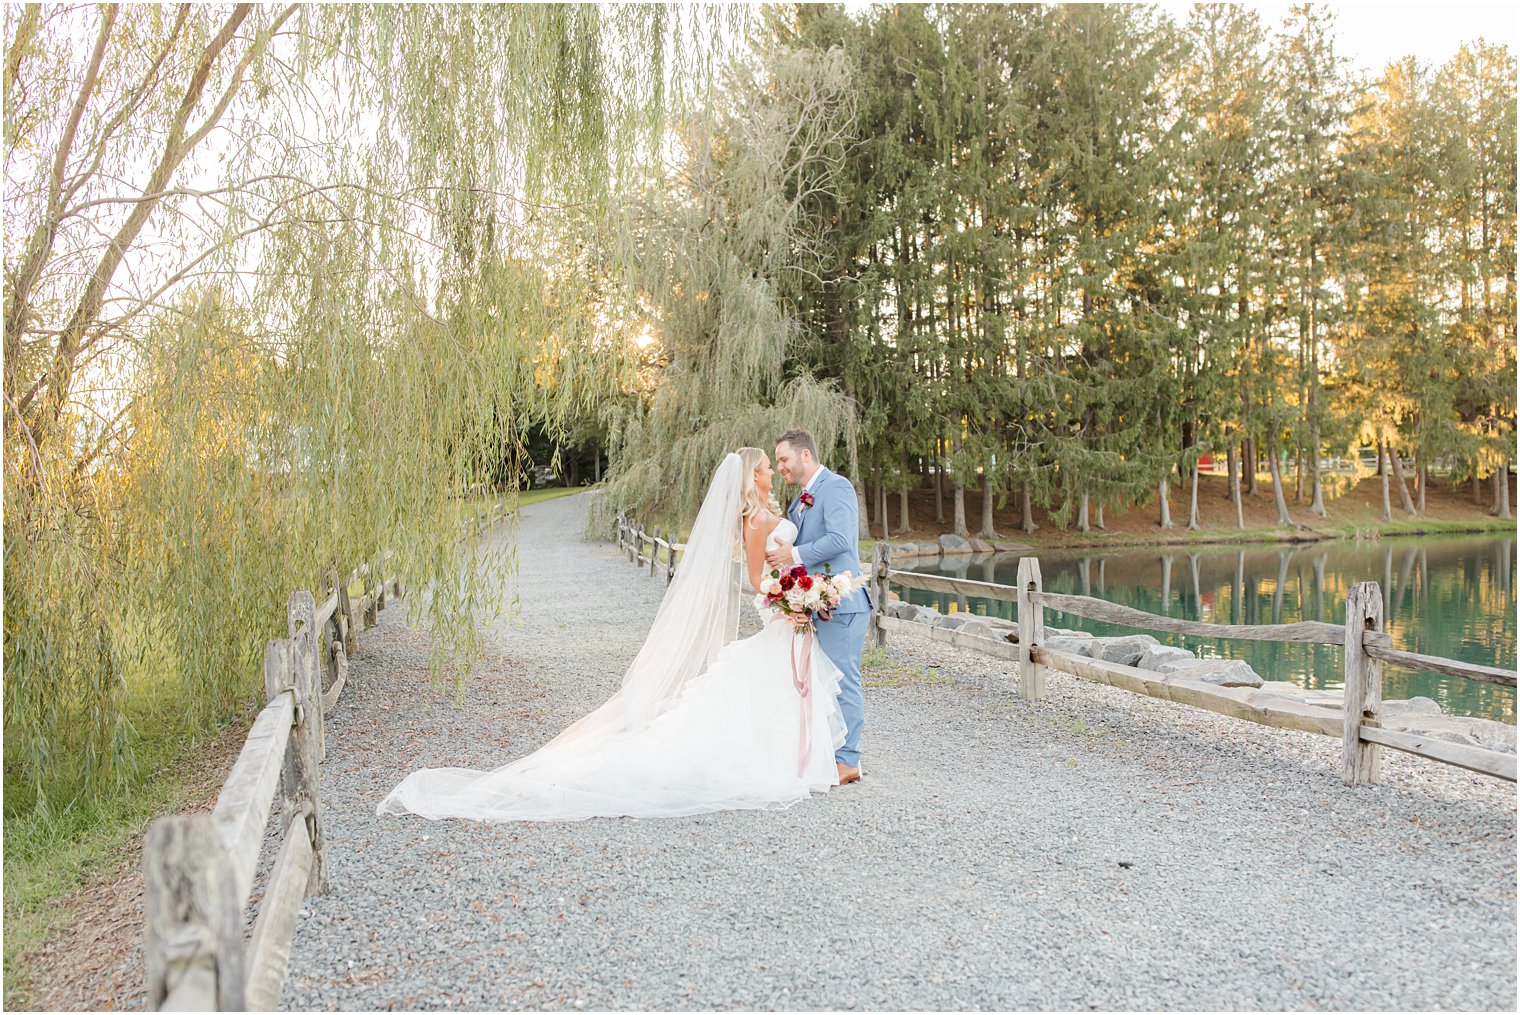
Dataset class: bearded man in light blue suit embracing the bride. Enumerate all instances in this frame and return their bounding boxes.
[766,430,871,786]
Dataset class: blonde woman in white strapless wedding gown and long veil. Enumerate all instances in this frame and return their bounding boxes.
[375,448,845,821]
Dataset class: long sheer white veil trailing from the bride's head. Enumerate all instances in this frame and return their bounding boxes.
[375,454,743,821]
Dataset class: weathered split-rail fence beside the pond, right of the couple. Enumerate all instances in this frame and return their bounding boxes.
[872,544,1515,786]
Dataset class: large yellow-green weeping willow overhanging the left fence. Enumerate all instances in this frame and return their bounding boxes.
[5,5,729,814]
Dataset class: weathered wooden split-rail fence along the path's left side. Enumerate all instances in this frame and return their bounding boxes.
[143,500,508,1012]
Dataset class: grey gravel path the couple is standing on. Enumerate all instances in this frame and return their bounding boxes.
[284,497,1515,1010]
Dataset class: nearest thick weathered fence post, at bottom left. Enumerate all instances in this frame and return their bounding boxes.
[143,814,246,1012]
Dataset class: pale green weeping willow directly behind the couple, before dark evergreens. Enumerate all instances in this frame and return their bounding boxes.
[590,37,854,530]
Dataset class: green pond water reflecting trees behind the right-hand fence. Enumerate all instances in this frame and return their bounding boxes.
[894,535,1515,723]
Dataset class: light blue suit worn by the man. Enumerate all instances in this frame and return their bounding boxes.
[786,468,871,766]
